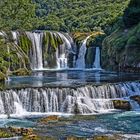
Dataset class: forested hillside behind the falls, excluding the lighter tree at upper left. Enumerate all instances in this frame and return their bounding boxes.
[34,0,129,32]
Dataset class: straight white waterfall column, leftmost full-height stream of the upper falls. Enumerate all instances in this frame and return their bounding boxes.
[26,32,43,70]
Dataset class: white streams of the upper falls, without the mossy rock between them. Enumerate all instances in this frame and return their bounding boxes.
[8,31,101,70]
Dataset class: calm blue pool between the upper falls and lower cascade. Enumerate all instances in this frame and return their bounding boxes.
[5,70,140,88]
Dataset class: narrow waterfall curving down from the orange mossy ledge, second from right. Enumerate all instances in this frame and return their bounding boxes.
[76,35,91,69]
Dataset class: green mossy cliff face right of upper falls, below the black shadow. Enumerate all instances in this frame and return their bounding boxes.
[102,24,140,71]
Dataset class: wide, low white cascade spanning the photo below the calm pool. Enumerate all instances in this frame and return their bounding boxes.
[0,83,140,114]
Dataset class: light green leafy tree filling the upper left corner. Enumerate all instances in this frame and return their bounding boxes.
[0,0,38,30]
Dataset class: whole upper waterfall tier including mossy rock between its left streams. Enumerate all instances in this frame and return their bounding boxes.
[0,31,101,70]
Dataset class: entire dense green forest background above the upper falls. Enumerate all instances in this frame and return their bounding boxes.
[0,0,129,32]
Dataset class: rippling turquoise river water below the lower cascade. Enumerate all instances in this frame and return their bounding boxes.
[0,111,140,138]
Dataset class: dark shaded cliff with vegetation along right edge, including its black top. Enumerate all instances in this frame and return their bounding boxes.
[102,0,140,72]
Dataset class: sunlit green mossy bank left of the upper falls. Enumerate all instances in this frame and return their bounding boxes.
[0,32,31,81]
